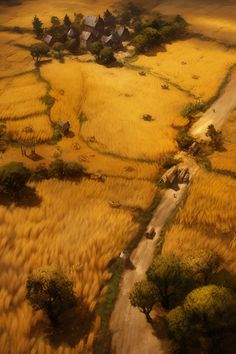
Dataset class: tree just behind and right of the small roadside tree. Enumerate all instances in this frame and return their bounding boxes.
[147,255,190,309]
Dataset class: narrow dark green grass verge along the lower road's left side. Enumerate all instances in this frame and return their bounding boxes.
[93,189,161,354]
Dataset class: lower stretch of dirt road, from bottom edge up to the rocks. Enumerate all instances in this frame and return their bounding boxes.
[110,155,196,354]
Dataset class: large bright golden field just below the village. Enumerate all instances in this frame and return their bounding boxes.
[41,60,188,160]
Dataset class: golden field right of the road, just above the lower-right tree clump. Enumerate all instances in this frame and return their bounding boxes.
[163,170,236,272]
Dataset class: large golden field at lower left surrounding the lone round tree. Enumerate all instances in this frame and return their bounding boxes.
[0,178,156,354]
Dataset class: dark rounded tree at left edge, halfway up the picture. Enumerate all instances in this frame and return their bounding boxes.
[0,162,31,196]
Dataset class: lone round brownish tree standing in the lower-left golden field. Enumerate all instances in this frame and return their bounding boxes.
[26,266,76,326]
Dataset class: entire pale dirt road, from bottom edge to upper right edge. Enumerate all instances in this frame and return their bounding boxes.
[110,65,236,354]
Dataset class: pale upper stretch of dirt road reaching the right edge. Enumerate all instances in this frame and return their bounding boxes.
[190,68,236,139]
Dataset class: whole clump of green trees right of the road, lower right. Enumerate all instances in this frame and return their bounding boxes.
[130,251,236,353]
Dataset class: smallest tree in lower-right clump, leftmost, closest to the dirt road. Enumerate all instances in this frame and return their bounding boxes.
[129,280,160,322]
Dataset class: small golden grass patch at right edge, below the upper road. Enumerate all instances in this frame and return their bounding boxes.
[210,112,236,172]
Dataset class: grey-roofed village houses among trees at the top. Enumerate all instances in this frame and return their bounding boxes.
[44,16,130,49]
